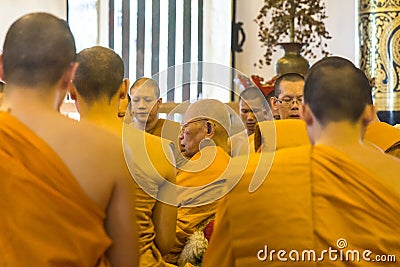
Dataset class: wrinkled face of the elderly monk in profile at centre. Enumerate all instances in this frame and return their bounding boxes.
[179,119,207,158]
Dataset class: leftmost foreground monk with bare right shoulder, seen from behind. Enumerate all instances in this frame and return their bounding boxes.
[0,13,138,267]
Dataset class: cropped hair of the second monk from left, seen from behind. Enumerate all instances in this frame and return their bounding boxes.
[74,46,124,103]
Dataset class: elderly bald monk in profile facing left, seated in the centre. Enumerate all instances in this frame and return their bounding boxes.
[165,99,230,266]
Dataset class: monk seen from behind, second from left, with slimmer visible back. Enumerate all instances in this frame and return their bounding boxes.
[70,46,177,266]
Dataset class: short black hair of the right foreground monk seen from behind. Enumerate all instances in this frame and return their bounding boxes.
[304,57,372,126]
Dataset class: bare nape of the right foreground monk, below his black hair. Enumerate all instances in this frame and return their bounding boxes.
[314,122,362,151]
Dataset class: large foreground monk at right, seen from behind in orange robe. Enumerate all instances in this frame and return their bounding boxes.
[203,57,400,266]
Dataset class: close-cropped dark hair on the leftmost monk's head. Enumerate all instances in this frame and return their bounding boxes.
[3,13,76,87]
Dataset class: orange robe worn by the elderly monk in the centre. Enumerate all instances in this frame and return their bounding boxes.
[164,147,230,264]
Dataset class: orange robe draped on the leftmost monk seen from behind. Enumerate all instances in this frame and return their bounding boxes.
[0,112,111,267]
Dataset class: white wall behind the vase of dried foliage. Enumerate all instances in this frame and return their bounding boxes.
[236,0,358,80]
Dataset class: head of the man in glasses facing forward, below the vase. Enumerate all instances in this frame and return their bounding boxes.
[270,73,304,120]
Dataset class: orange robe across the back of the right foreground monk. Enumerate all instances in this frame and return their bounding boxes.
[203,145,400,267]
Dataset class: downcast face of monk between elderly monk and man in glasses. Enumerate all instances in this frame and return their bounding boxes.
[239,98,266,135]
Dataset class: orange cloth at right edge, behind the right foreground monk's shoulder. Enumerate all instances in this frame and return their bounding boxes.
[364,122,400,157]
